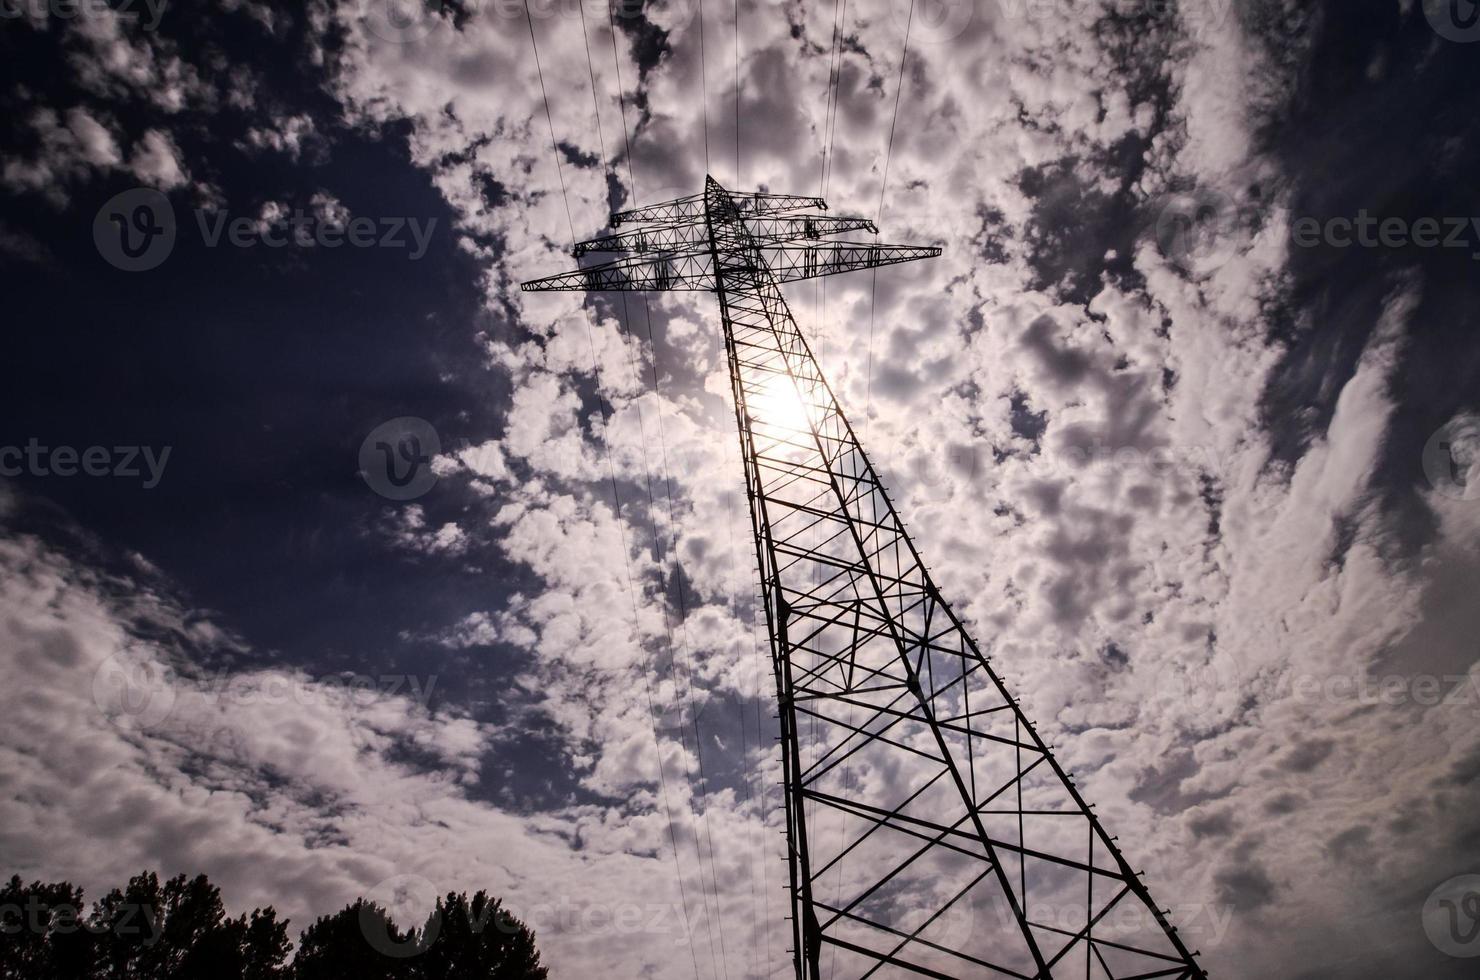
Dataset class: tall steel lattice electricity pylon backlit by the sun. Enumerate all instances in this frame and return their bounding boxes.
[522,178,1206,980]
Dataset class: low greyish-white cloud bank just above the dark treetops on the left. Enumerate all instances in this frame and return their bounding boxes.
[0,536,763,977]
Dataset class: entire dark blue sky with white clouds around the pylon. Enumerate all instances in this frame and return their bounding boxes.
[0,0,1480,980]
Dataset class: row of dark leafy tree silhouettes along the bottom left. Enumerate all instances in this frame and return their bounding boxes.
[0,872,548,980]
